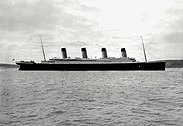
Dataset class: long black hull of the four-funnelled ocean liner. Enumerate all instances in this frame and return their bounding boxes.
[17,62,165,71]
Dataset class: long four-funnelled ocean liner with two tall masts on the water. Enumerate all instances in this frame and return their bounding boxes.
[16,36,165,71]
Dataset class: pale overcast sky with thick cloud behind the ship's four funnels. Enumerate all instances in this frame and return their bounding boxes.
[0,0,183,63]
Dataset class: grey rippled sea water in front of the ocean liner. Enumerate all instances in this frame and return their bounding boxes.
[0,68,183,126]
